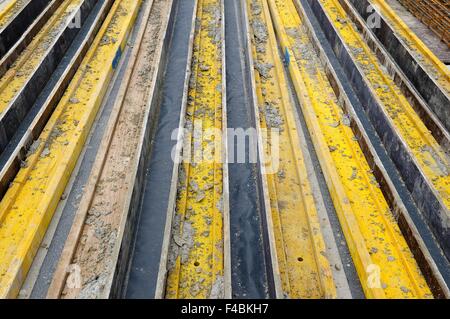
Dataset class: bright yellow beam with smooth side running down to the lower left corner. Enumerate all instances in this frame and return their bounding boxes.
[0,0,141,298]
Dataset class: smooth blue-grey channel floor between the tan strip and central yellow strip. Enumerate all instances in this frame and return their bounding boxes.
[124,0,195,299]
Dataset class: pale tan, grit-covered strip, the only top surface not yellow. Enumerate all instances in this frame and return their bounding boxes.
[61,0,169,298]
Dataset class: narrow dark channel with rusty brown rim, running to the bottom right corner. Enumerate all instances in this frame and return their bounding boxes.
[294,0,450,298]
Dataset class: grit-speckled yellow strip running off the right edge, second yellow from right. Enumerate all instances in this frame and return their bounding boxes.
[320,0,450,225]
